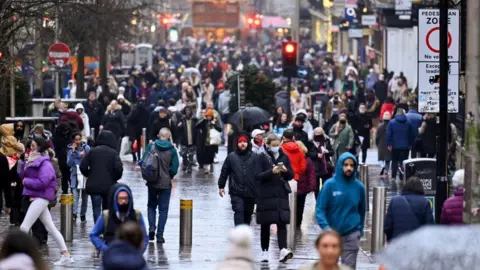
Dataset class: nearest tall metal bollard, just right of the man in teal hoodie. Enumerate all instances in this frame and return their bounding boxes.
[371,187,387,254]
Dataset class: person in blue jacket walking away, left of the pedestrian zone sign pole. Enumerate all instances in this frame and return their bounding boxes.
[387,109,418,180]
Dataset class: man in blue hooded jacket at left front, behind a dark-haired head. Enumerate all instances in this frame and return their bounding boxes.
[90,184,148,252]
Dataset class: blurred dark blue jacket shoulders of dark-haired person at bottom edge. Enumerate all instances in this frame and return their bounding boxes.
[100,241,148,270]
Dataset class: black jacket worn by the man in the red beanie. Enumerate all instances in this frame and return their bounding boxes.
[218,134,259,198]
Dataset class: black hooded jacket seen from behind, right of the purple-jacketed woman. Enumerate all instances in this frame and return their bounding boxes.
[80,130,123,194]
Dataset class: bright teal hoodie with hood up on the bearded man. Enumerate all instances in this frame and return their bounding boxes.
[315,152,365,236]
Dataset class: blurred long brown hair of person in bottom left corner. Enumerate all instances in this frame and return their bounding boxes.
[0,230,50,270]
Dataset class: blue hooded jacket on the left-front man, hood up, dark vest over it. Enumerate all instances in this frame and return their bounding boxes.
[90,184,149,253]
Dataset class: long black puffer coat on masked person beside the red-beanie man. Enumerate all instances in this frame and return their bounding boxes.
[257,149,293,224]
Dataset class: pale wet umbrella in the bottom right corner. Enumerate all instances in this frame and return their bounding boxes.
[377,226,480,270]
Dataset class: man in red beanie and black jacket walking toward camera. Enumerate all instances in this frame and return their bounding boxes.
[218,134,258,226]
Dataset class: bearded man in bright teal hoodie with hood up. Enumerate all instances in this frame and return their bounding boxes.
[315,152,365,269]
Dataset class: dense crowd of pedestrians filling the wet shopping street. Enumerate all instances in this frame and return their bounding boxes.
[0,36,463,269]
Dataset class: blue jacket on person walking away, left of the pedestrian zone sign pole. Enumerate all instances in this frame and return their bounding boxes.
[387,114,418,149]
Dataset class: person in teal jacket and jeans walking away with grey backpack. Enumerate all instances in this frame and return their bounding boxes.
[140,128,179,244]
